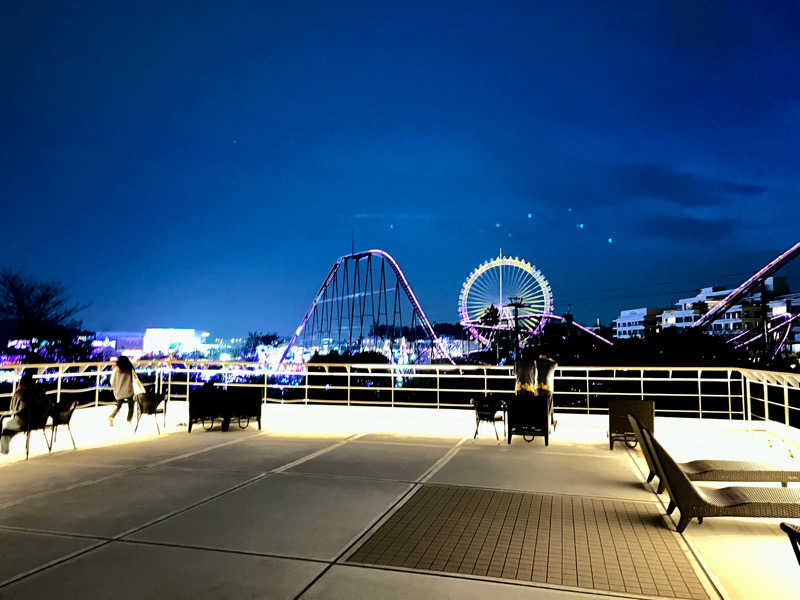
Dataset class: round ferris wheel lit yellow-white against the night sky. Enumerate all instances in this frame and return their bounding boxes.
[458,252,553,345]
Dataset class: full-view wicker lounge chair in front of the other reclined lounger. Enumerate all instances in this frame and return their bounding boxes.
[642,428,800,533]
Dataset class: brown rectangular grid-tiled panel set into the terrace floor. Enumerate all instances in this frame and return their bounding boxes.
[348,486,708,600]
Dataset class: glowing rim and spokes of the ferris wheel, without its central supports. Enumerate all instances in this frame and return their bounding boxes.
[459,254,553,345]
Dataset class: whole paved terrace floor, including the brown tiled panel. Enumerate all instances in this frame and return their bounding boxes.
[0,402,800,600]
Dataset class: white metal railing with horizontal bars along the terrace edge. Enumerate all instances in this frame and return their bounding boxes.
[0,360,800,428]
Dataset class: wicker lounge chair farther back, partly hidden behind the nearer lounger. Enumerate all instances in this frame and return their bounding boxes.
[628,414,800,494]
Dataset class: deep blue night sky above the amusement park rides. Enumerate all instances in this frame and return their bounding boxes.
[0,0,800,334]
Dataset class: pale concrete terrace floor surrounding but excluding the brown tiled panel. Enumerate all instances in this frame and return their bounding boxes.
[0,402,800,600]
